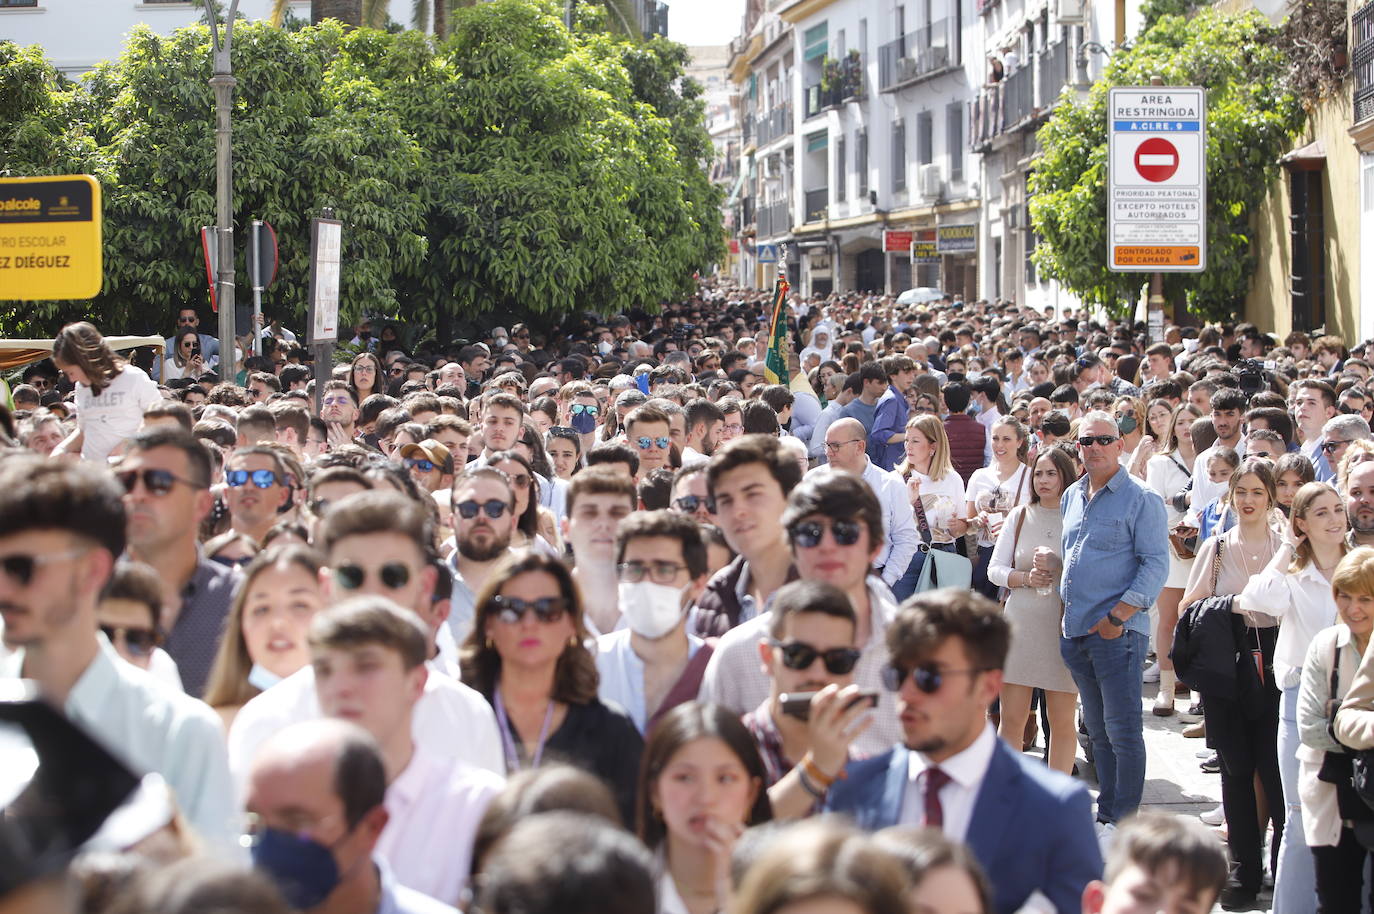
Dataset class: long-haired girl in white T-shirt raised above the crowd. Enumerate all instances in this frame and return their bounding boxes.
[52,320,162,463]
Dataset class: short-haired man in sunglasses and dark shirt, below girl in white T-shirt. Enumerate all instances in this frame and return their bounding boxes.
[115,426,239,697]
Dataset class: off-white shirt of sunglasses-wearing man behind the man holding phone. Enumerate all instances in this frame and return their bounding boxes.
[697,576,903,756]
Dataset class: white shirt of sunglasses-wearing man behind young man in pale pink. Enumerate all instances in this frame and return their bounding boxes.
[229,664,506,788]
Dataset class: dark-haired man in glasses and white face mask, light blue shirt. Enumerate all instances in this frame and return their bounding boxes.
[596,508,712,733]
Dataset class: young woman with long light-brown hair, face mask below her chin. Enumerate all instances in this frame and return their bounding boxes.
[205,546,324,731]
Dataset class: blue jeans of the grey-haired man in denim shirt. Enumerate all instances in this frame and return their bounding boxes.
[1059,631,1150,822]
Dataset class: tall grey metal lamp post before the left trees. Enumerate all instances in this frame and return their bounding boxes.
[205,0,239,382]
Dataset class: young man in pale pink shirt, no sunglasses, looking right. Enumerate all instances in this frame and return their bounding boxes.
[309,597,504,904]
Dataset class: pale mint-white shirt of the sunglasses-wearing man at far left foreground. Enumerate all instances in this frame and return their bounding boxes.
[0,635,242,854]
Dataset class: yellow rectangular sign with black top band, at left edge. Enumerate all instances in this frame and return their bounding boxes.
[0,175,103,301]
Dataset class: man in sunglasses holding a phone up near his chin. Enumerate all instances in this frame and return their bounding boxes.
[743,580,878,819]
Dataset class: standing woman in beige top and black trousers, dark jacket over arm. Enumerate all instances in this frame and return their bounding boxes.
[1180,458,1285,907]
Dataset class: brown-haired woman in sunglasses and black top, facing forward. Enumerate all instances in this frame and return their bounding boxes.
[459,551,643,822]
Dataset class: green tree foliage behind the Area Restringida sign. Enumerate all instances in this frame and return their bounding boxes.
[1029,8,1304,317]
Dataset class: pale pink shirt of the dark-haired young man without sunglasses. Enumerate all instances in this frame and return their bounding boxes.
[376,746,506,904]
